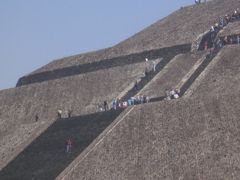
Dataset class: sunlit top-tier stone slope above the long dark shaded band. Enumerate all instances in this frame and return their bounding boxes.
[31,0,240,73]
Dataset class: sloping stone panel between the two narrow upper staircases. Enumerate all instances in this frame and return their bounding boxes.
[141,52,206,98]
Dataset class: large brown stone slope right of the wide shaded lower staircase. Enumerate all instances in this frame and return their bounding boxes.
[56,95,240,180]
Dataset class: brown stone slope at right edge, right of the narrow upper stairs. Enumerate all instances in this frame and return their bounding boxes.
[187,45,240,98]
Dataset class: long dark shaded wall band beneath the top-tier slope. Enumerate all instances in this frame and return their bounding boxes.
[17,44,190,86]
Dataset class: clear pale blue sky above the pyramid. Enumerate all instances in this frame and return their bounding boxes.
[0,0,194,90]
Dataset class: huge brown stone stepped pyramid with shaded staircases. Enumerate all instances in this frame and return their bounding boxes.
[0,0,240,180]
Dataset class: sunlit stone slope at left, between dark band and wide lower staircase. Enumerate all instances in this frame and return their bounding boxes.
[0,63,146,168]
